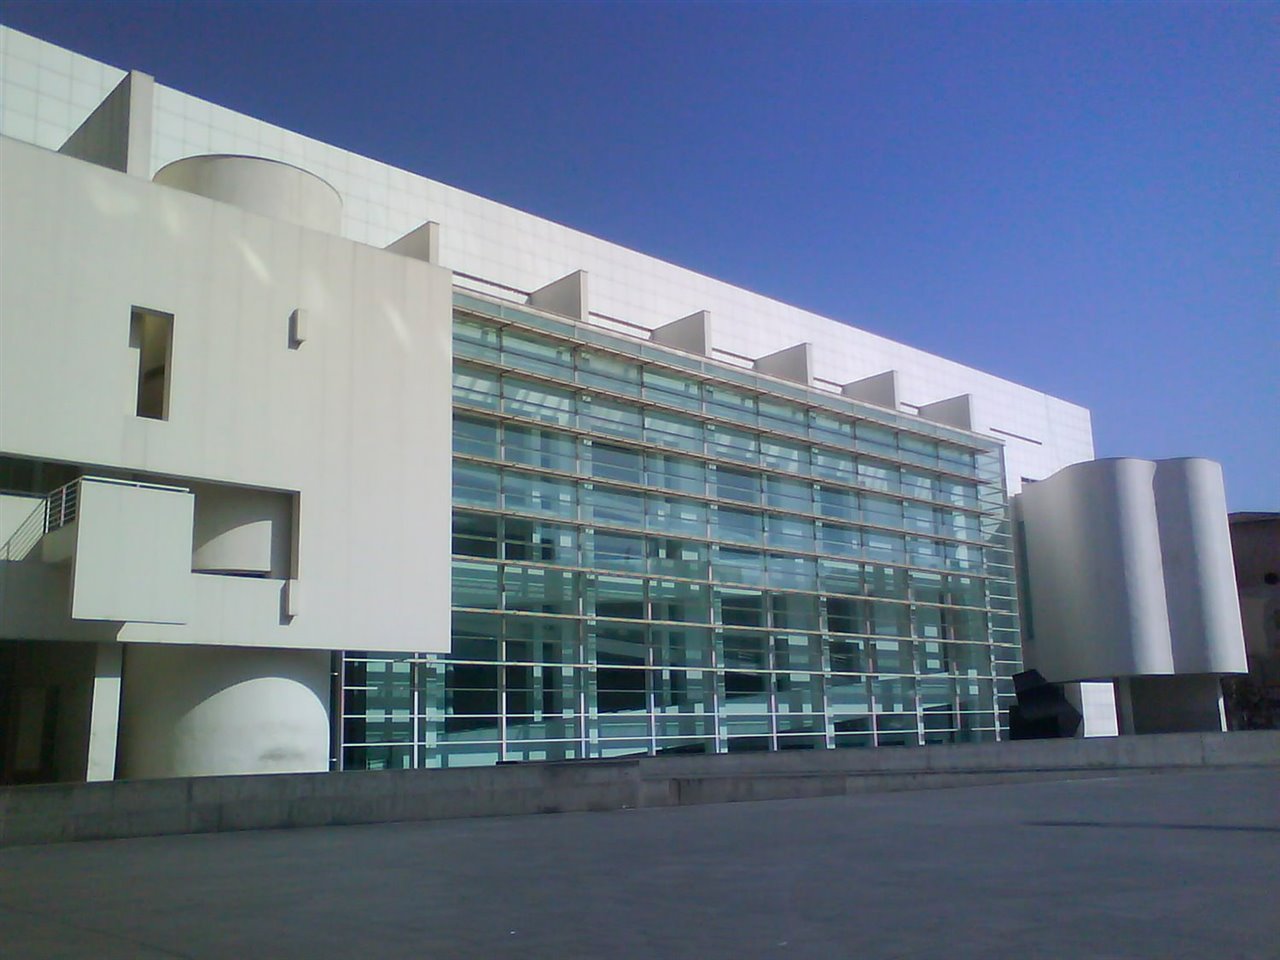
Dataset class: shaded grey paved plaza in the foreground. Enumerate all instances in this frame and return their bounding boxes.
[0,771,1280,960]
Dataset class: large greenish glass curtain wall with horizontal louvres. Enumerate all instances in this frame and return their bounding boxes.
[340,292,1020,769]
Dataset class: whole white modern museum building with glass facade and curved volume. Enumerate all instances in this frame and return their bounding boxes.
[0,28,1245,782]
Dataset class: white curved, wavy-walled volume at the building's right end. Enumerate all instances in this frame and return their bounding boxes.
[1018,460,1245,682]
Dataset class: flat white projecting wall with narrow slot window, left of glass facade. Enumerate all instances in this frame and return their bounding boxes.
[0,140,452,650]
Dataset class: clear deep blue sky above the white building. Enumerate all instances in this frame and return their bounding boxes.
[0,0,1280,511]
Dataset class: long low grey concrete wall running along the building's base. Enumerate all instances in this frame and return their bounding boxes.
[0,731,1280,846]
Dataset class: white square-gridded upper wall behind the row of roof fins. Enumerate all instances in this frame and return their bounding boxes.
[0,28,1093,492]
